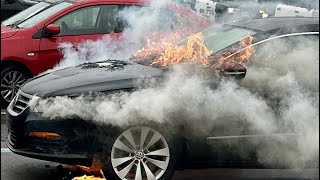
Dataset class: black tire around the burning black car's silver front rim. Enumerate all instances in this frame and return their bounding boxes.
[101,126,179,180]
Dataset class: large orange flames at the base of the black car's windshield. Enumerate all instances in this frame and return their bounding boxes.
[134,33,254,69]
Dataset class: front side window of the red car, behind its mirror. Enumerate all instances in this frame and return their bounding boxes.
[54,5,123,36]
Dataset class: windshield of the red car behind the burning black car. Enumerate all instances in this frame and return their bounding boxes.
[18,2,72,29]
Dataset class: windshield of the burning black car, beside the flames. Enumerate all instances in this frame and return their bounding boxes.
[202,25,257,53]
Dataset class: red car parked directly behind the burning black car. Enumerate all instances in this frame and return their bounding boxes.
[1,0,210,106]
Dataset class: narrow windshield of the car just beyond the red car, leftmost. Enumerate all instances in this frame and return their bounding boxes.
[1,2,50,26]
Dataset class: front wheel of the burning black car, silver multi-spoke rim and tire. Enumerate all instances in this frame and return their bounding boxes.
[104,126,176,180]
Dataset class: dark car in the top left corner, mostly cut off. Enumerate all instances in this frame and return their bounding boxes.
[1,0,39,21]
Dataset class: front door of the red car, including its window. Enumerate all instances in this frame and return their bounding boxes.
[39,5,120,69]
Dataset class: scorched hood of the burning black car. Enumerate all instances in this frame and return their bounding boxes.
[21,62,163,97]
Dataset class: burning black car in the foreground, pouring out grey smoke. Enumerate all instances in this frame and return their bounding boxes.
[6,18,319,179]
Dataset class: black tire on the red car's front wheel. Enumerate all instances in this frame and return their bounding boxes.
[1,66,30,108]
